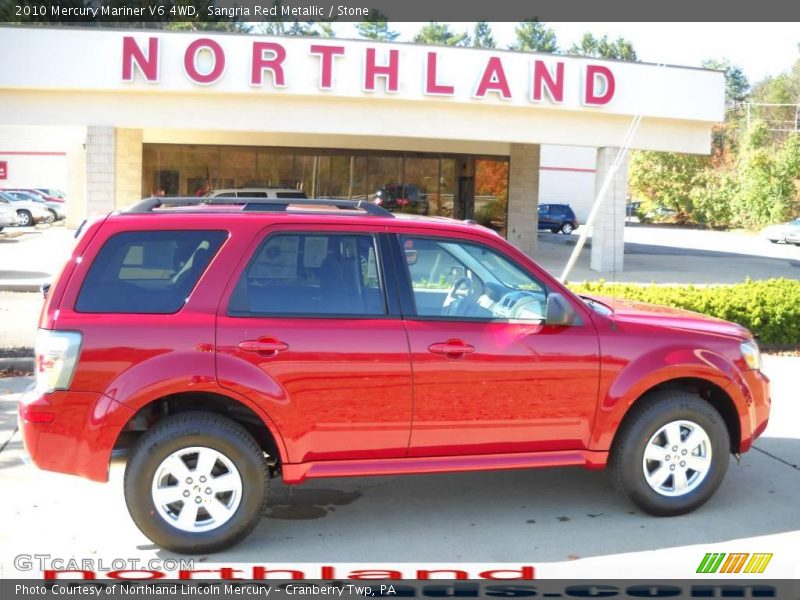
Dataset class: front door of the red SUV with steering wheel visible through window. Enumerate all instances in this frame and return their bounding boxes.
[398,236,600,456]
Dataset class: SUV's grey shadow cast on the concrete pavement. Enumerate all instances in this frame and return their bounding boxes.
[148,438,800,565]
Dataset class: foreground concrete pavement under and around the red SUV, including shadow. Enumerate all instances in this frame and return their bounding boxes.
[0,357,800,578]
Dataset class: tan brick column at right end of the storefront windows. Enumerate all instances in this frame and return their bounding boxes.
[508,144,540,257]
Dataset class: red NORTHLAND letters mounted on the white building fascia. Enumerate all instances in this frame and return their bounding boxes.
[122,36,616,106]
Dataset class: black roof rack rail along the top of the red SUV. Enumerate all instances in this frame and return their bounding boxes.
[122,196,394,217]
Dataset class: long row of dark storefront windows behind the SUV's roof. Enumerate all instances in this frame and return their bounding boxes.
[142,144,508,231]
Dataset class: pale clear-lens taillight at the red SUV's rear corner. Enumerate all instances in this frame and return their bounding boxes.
[34,329,83,393]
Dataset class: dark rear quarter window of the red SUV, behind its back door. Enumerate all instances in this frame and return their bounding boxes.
[75,230,228,314]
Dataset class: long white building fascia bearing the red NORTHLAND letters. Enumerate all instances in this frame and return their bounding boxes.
[0,27,725,127]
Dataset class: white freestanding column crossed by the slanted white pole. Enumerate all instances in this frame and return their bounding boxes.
[590,148,628,273]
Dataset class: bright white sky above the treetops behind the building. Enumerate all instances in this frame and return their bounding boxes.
[336,22,800,83]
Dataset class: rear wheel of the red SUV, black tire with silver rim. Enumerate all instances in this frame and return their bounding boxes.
[125,412,269,554]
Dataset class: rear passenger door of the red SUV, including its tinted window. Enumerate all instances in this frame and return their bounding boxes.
[217,227,411,463]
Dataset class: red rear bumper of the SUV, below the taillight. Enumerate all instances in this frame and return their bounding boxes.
[18,389,134,481]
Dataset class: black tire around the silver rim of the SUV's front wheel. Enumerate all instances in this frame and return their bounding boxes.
[609,390,730,517]
